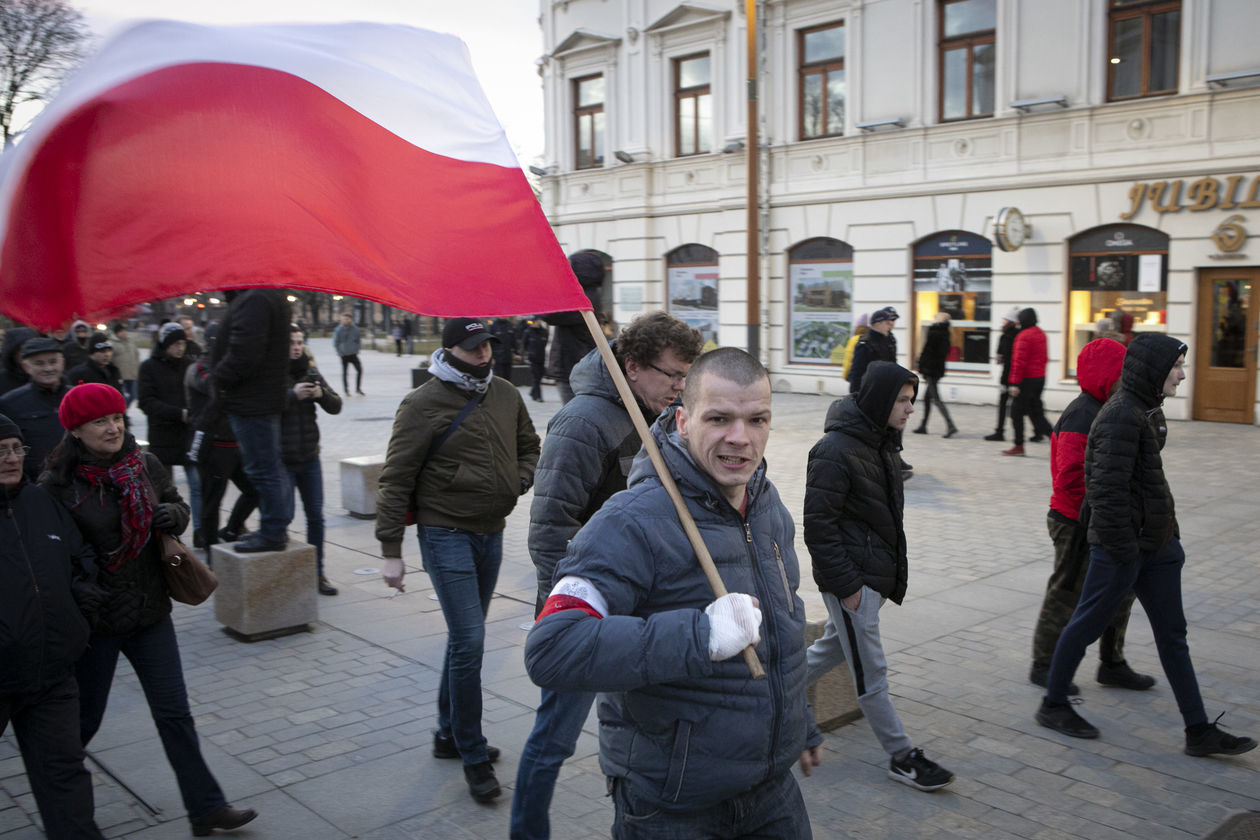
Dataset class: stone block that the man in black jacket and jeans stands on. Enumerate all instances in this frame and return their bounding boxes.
[210,540,319,641]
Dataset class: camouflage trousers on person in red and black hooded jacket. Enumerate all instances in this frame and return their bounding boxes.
[1032,511,1137,667]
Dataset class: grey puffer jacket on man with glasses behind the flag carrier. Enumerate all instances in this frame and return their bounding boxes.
[529,350,655,615]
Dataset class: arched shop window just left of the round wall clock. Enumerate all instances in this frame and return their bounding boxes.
[910,230,993,373]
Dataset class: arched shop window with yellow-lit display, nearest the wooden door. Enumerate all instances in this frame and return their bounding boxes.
[1067,224,1168,377]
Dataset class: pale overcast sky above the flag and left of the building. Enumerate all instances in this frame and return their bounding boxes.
[71,0,543,166]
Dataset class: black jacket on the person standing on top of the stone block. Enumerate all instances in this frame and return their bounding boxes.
[210,288,290,417]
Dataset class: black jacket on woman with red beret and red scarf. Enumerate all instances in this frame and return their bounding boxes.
[42,434,189,636]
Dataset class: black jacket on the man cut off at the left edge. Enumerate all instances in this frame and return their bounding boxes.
[0,481,96,696]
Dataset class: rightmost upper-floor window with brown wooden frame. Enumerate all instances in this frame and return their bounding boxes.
[1108,0,1181,99]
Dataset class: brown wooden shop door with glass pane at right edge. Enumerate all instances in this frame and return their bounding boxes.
[1193,268,1260,423]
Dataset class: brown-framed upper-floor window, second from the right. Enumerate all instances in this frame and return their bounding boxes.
[939,0,997,122]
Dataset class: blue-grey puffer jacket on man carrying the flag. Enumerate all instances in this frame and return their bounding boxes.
[525,413,822,811]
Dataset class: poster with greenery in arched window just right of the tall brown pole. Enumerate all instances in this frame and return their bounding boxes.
[789,261,853,364]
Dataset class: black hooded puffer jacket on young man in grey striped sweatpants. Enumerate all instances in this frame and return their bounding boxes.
[805,363,915,603]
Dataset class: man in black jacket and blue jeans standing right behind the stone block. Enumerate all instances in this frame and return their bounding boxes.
[280,325,341,596]
